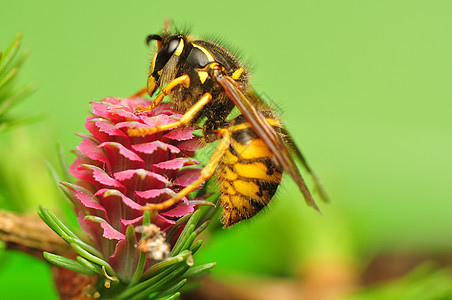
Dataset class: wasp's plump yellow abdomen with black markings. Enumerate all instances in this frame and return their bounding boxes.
[217,123,282,227]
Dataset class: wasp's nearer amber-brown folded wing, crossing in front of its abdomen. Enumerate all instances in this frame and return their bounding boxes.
[215,73,320,211]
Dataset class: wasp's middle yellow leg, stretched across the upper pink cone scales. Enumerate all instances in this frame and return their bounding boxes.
[128,93,212,136]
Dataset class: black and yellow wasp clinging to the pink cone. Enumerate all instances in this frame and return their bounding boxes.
[129,25,326,227]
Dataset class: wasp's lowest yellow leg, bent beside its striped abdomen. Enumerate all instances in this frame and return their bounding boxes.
[141,129,231,210]
